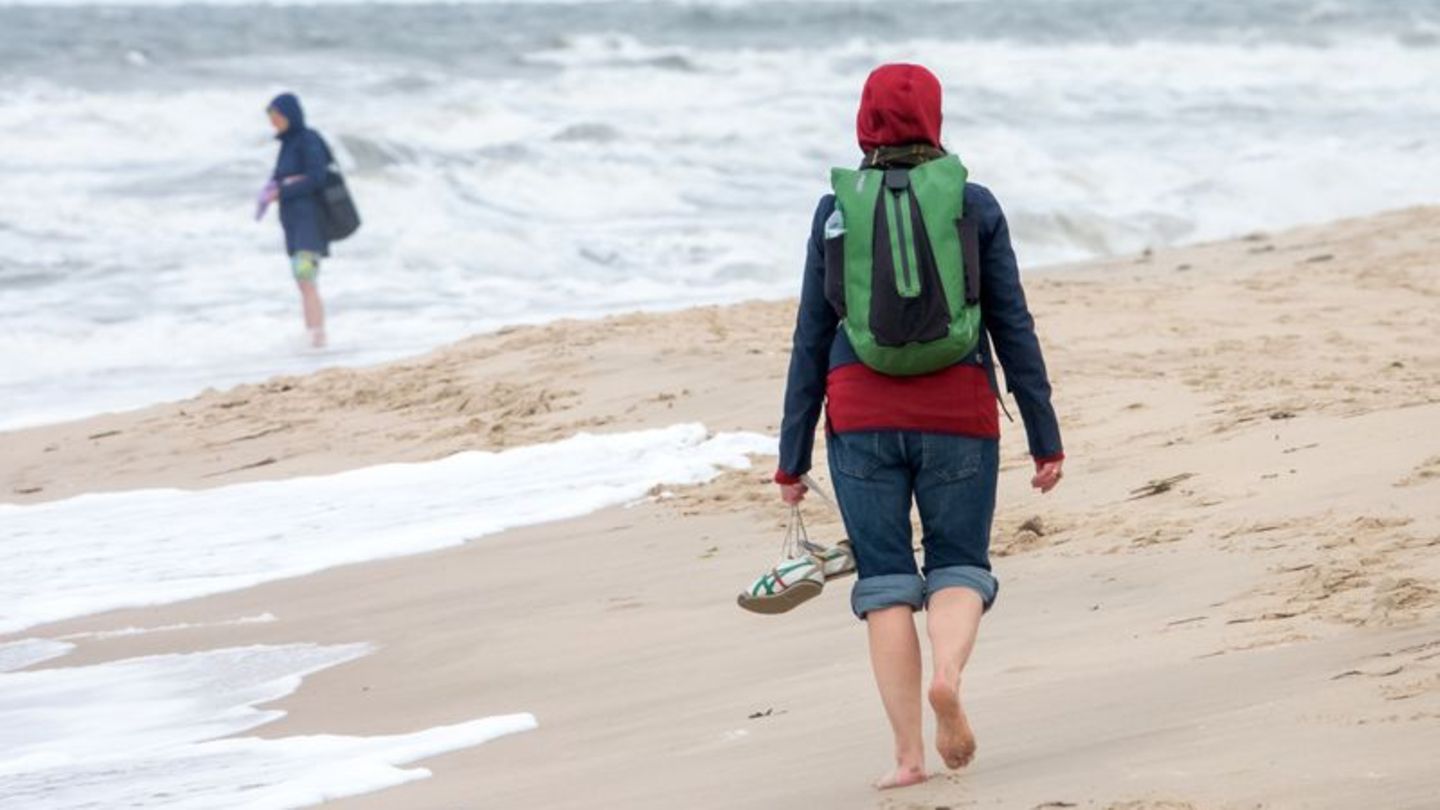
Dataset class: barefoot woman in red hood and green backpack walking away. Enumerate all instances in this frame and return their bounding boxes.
[775,65,1064,788]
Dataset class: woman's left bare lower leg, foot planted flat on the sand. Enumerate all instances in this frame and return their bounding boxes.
[865,605,926,790]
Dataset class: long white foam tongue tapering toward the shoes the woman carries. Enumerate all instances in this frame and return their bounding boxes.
[0,424,775,633]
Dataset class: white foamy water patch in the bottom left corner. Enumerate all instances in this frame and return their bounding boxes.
[0,644,537,810]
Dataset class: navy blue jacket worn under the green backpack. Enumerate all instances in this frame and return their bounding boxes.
[780,183,1063,476]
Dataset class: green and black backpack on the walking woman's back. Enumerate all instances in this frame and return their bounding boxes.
[825,154,981,376]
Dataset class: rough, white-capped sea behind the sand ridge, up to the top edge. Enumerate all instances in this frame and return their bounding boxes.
[0,0,1440,427]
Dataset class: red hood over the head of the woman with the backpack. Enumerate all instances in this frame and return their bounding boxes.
[855,65,940,151]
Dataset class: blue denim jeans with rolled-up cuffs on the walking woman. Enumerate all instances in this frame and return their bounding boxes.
[828,431,999,618]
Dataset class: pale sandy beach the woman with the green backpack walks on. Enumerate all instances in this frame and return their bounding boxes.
[0,209,1440,810]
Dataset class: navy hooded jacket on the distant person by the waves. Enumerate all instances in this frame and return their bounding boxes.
[271,92,330,257]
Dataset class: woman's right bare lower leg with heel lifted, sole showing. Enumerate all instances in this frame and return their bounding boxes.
[927,588,985,768]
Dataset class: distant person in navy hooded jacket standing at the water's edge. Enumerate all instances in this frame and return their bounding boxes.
[256,92,331,349]
